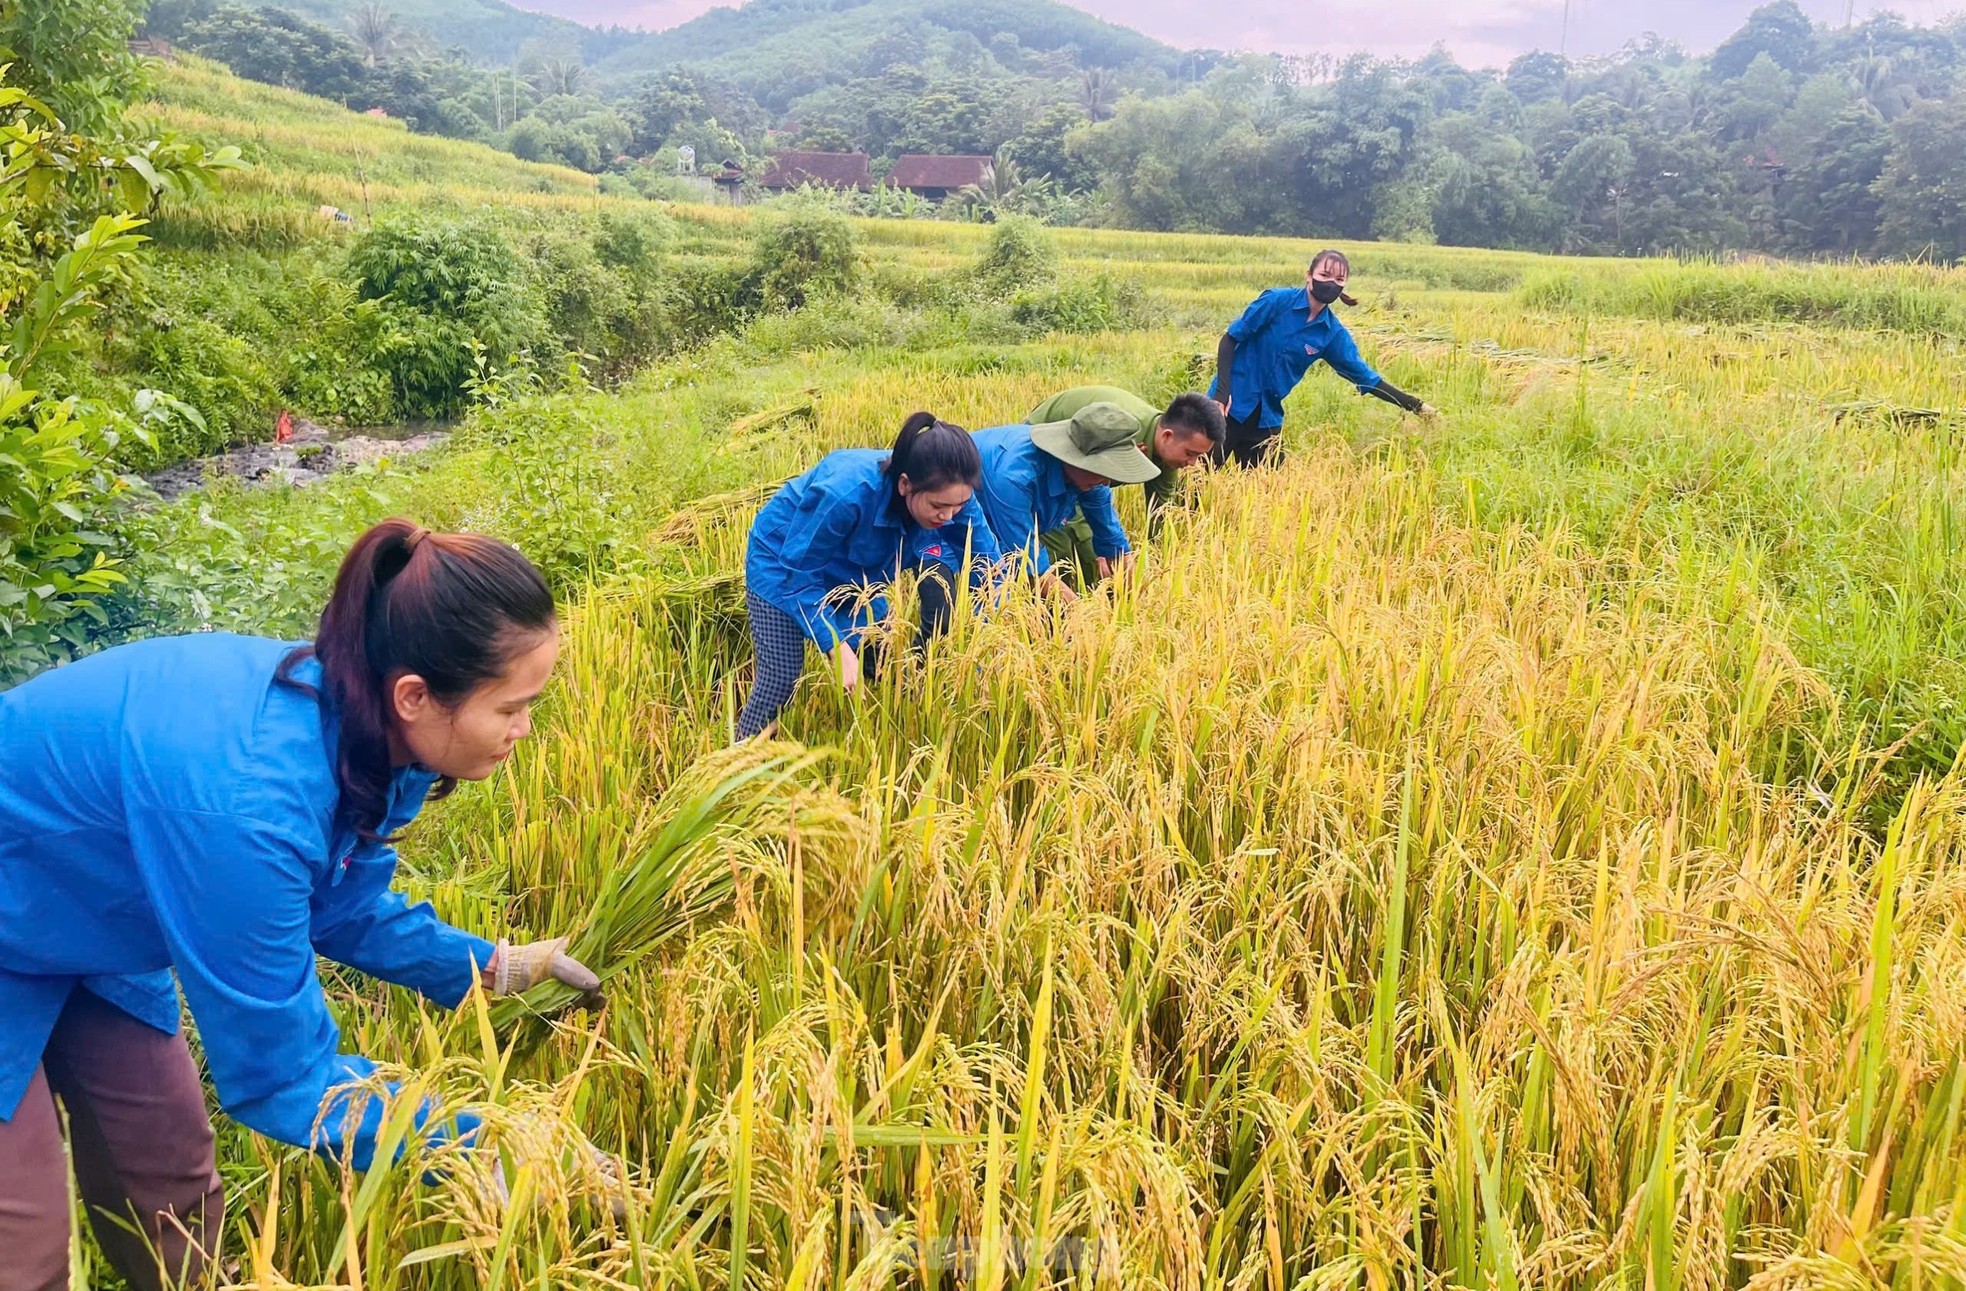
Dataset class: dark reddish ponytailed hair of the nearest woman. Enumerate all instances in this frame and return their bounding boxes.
[277,519,554,841]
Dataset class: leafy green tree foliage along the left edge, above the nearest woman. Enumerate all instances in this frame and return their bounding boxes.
[0,32,242,684]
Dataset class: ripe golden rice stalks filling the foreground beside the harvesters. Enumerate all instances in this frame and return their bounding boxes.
[203,440,1966,1289]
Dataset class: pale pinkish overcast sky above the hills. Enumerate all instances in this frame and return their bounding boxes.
[515,0,1966,67]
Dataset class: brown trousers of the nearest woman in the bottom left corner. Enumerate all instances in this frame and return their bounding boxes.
[0,990,224,1291]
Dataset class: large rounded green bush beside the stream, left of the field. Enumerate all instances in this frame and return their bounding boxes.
[348,216,547,417]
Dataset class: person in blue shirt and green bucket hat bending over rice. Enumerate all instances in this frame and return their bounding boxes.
[975,403,1160,599]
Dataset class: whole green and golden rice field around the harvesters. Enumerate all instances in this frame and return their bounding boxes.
[111,57,1966,1291]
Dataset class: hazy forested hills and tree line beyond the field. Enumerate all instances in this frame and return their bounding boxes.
[149,0,1966,261]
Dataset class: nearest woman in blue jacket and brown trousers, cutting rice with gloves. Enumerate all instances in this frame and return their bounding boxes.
[0,521,598,1291]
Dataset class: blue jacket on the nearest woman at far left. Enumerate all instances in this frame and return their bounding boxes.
[0,635,492,1167]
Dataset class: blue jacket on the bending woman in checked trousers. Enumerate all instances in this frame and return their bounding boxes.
[743,448,1003,650]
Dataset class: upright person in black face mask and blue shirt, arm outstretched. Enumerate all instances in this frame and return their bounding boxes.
[1209,252,1435,466]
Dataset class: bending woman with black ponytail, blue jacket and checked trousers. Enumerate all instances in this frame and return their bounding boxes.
[737,413,1001,739]
